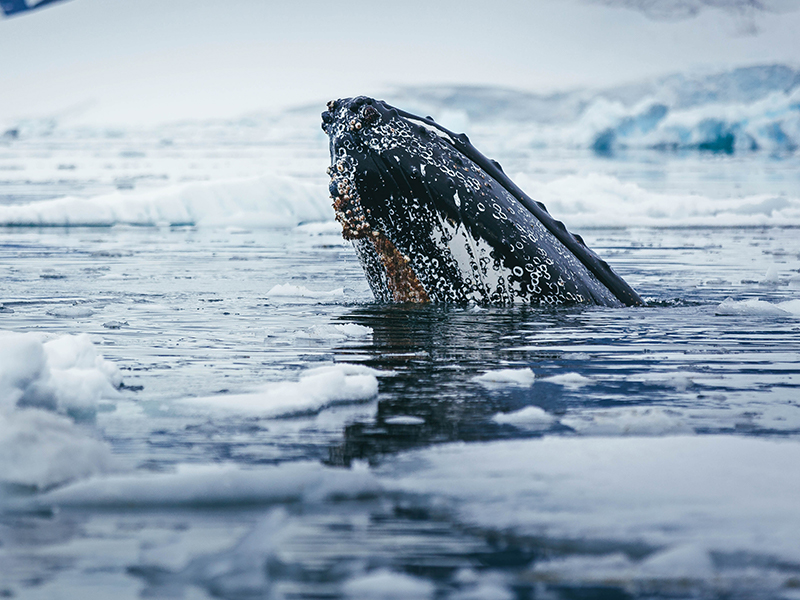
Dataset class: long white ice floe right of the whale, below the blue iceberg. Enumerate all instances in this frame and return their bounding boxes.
[513,173,800,229]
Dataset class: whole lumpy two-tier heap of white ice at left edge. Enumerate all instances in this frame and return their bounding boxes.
[0,331,122,489]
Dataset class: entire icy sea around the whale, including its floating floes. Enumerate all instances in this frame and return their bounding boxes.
[0,81,800,599]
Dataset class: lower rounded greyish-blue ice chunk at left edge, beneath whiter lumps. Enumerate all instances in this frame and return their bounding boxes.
[0,408,114,490]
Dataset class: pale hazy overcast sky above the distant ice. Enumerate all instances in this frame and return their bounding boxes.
[0,0,800,124]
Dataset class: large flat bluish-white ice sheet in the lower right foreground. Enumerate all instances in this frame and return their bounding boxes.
[378,436,800,578]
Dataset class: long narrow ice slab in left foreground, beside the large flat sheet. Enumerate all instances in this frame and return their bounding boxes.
[35,461,381,507]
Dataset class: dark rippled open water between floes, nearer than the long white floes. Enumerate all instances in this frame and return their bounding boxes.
[0,221,800,598]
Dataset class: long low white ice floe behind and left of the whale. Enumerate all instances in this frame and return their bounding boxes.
[0,175,333,228]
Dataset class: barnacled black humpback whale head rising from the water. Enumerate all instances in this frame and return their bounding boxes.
[322,96,642,307]
